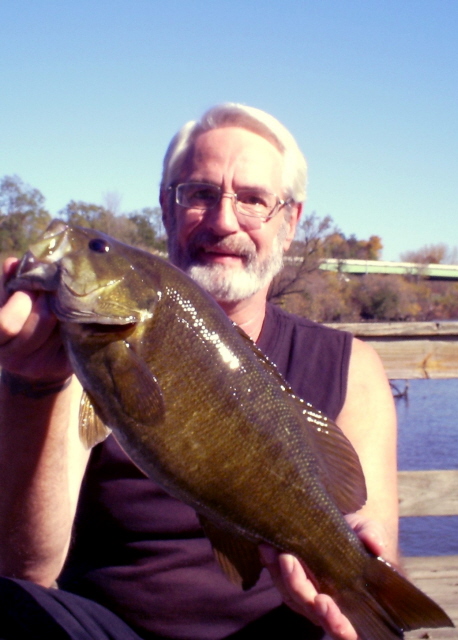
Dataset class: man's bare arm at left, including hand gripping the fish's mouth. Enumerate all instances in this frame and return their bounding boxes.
[0,263,88,586]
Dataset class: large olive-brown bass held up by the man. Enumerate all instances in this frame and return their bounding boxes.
[7,220,453,640]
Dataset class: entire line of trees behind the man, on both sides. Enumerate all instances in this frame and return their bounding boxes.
[0,176,458,322]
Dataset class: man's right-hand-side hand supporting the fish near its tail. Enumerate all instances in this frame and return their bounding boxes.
[259,514,386,640]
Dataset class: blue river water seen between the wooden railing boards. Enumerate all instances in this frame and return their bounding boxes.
[395,379,458,556]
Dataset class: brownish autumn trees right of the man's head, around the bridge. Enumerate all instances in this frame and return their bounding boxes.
[270,214,458,322]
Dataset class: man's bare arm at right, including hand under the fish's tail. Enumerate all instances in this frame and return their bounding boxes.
[261,339,398,640]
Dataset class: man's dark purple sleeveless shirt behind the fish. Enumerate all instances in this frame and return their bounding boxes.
[59,305,351,640]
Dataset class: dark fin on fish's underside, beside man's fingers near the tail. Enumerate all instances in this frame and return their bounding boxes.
[199,516,263,591]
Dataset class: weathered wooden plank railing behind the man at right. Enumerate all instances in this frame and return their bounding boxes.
[328,322,458,640]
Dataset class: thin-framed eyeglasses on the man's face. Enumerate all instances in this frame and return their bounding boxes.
[169,182,292,220]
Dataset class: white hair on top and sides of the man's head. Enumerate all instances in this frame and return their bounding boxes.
[161,102,307,203]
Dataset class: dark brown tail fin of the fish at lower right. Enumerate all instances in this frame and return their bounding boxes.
[342,557,454,640]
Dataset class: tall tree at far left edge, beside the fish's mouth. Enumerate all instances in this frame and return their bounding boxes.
[0,176,51,254]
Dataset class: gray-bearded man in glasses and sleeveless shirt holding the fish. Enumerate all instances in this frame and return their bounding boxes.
[0,104,397,640]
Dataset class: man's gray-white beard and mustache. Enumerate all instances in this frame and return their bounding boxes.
[169,222,288,302]
